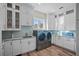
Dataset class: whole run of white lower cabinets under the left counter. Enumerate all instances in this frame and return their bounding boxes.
[0,38,36,56]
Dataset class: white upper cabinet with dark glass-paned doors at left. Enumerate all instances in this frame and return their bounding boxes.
[1,3,21,30]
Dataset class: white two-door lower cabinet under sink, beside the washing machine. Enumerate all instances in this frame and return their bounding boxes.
[21,38,36,53]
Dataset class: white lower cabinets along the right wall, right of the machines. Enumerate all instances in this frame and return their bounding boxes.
[54,37,76,52]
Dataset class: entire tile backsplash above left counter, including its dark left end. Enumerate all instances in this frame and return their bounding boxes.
[2,26,33,39]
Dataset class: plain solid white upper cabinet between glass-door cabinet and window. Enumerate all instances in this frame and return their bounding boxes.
[21,4,33,26]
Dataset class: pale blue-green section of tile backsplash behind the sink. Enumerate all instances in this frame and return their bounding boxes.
[12,26,33,38]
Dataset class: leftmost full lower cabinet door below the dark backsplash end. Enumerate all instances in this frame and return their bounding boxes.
[4,41,12,56]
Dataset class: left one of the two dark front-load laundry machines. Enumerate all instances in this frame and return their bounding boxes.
[36,30,46,50]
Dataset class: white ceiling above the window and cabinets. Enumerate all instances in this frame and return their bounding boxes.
[31,3,73,13]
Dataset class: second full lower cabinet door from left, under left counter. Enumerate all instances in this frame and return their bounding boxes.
[12,40,21,55]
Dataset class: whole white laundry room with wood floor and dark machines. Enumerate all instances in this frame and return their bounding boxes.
[0,3,79,56]
